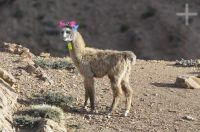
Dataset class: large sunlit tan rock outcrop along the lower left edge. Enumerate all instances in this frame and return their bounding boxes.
[0,69,17,132]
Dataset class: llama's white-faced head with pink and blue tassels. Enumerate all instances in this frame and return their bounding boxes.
[58,20,79,42]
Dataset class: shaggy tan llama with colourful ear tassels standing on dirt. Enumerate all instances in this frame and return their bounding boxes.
[59,21,136,116]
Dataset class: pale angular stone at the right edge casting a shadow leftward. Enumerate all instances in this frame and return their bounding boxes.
[175,75,200,89]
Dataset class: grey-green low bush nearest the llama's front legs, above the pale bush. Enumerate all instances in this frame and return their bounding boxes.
[43,92,73,107]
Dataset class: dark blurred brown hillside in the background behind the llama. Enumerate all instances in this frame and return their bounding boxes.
[0,0,200,60]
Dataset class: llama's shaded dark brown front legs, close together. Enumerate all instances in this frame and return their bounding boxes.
[84,77,95,112]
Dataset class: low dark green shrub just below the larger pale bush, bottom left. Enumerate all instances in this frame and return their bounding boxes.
[13,115,41,128]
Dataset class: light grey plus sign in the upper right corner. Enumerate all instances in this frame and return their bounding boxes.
[176,3,198,25]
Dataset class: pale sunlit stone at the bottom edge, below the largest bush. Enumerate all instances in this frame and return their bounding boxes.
[36,119,67,132]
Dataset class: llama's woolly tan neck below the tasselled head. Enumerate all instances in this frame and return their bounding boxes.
[69,31,85,66]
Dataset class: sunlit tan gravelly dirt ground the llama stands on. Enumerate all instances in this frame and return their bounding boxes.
[0,52,200,132]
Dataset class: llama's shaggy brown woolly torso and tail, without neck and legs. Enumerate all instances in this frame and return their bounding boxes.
[83,48,136,77]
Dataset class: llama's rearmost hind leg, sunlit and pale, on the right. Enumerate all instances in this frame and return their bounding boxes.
[121,77,133,116]
